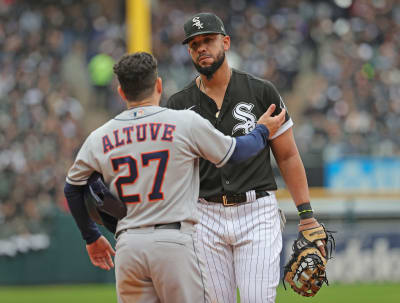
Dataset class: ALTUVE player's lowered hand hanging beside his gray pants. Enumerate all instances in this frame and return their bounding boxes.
[86,236,115,270]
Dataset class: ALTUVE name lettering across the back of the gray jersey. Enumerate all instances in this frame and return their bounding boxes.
[102,123,176,154]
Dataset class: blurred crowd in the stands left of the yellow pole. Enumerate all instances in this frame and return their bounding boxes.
[0,0,125,239]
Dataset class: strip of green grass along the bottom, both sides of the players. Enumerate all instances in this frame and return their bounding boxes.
[0,284,400,303]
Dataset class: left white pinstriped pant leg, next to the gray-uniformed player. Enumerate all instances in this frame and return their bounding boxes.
[196,202,236,303]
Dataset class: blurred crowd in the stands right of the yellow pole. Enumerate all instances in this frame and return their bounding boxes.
[153,0,400,159]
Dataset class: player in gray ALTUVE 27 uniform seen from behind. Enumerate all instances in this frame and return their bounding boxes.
[64,52,285,303]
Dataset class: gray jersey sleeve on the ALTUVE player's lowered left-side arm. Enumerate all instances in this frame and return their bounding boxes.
[66,136,98,185]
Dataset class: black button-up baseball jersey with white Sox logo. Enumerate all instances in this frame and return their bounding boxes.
[167,69,293,197]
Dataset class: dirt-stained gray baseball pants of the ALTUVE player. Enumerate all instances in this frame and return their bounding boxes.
[115,222,210,303]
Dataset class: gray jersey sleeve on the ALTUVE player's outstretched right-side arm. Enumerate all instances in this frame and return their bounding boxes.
[188,111,236,167]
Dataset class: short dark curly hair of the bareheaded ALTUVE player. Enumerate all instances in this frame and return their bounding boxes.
[114,52,158,101]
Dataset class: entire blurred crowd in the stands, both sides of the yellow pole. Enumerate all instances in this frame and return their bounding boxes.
[0,0,400,242]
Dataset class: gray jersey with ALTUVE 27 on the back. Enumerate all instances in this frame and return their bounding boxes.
[67,106,236,231]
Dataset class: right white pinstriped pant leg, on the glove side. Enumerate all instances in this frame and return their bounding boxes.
[234,195,282,303]
